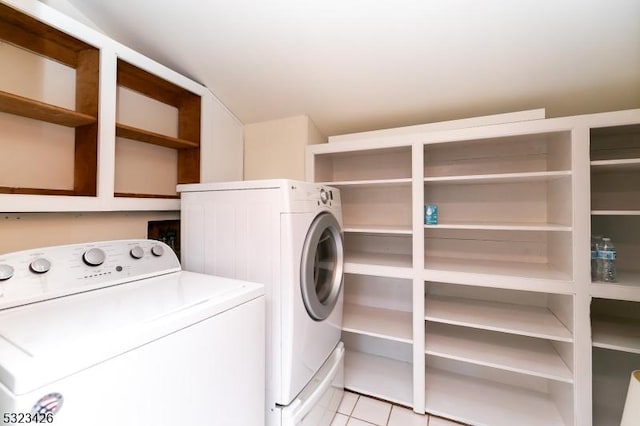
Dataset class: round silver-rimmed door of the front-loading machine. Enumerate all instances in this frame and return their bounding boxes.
[300,213,344,321]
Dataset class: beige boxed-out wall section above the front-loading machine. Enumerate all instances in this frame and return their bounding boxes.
[244,115,327,180]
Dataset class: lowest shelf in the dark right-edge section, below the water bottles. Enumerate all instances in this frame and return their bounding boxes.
[591,317,640,354]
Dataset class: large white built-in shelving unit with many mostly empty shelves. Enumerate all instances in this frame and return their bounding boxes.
[307,110,640,426]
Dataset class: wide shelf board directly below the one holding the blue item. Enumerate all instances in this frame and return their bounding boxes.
[424,255,574,294]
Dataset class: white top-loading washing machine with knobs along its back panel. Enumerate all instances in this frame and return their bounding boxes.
[0,240,265,426]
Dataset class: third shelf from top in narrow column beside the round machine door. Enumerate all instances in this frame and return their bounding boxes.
[344,251,413,278]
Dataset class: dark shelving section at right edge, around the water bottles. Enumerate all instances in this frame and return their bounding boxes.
[589,121,640,426]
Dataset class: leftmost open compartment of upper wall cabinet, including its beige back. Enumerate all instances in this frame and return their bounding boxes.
[0,4,100,196]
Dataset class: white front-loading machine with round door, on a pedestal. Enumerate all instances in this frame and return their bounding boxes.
[178,180,344,426]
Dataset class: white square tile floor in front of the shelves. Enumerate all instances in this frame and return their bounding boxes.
[331,391,460,426]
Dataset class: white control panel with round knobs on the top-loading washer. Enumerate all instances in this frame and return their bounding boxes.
[0,240,180,309]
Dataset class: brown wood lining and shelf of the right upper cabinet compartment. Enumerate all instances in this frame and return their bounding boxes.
[116,60,201,185]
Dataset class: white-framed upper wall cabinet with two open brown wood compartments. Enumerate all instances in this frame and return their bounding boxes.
[0,0,243,212]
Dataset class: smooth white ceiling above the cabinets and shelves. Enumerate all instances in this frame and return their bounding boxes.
[58,0,640,135]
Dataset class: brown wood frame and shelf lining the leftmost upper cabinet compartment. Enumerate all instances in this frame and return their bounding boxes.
[0,4,100,196]
